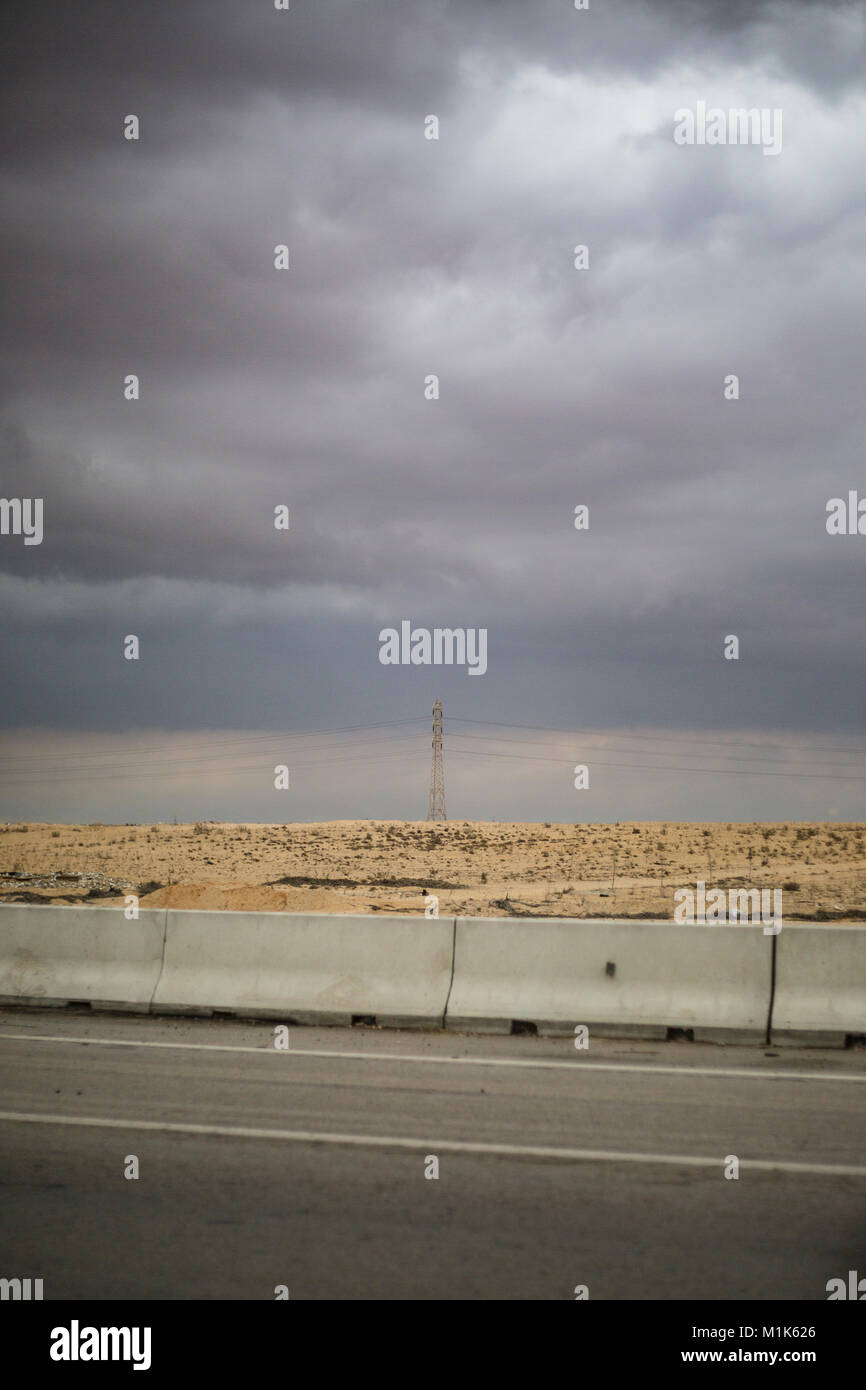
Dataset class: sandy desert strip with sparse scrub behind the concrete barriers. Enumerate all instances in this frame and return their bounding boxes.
[0,820,866,920]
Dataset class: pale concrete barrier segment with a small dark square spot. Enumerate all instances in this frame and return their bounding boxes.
[445,917,784,1043]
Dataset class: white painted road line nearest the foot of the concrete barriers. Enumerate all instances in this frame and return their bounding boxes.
[0,1033,866,1083]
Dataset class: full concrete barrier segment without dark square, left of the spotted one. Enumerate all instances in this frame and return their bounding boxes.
[153,912,455,1027]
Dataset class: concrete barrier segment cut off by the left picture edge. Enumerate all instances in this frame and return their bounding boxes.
[0,904,165,1013]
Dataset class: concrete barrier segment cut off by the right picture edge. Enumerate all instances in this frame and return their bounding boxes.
[771,924,866,1047]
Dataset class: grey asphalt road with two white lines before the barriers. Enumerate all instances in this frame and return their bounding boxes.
[0,1011,866,1300]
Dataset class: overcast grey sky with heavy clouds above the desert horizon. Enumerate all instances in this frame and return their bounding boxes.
[0,0,866,821]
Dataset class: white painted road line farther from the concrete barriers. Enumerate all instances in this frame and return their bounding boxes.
[0,1111,866,1177]
